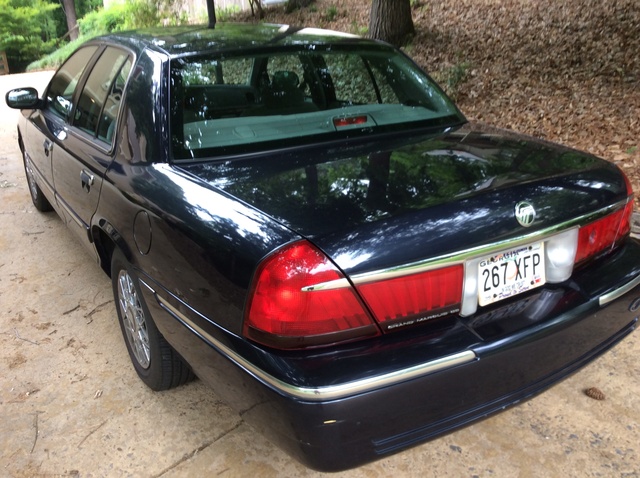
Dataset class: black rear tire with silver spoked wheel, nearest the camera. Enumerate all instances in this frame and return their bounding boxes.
[111,249,194,391]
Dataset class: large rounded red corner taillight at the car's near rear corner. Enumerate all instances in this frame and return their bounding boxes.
[244,241,380,348]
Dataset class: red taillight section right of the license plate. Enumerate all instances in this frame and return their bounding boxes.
[575,200,633,264]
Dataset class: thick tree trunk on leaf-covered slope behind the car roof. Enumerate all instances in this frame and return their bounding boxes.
[369,0,415,46]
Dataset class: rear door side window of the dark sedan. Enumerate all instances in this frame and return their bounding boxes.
[73,47,131,141]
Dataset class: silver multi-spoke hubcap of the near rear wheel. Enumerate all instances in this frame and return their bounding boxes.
[118,271,151,369]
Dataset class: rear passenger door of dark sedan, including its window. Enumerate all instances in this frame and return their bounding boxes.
[53,46,132,242]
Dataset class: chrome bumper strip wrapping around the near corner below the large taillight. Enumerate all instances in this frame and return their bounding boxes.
[140,280,477,402]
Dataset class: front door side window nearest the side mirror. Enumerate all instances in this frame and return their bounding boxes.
[46,46,98,121]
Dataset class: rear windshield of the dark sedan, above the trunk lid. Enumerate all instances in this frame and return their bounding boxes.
[170,44,463,160]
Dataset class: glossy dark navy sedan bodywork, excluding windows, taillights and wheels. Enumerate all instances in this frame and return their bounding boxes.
[6,25,640,471]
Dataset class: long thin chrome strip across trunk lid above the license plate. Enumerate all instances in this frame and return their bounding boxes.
[302,199,630,292]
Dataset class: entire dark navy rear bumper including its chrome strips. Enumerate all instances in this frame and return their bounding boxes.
[145,241,640,471]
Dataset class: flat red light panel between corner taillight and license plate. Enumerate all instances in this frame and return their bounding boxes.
[357,264,464,330]
